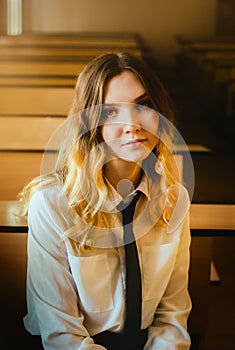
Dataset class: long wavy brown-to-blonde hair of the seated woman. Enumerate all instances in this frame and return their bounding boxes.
[18,53,178,249]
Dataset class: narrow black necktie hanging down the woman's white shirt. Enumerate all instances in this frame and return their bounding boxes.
[118,191,142,342]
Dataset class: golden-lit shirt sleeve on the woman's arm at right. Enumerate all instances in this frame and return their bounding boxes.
[144,213,191,350]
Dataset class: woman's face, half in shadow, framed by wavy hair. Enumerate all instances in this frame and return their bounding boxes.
[101,70,159,163]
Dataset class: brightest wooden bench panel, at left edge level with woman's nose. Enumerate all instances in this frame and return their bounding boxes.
[0,116,66,151]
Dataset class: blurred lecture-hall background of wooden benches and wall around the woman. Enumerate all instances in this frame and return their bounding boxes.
[0,0,235,350]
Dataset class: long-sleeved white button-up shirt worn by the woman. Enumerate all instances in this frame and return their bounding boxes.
[24,179,191,350]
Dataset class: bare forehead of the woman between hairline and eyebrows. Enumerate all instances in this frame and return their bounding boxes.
[104,71,146,103]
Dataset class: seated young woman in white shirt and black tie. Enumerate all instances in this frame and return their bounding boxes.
[20,53,191,350]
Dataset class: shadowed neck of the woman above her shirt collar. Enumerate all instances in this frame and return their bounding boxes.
[104,159,142,198]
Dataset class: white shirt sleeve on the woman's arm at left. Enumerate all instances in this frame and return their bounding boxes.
[24,191,105,350]
